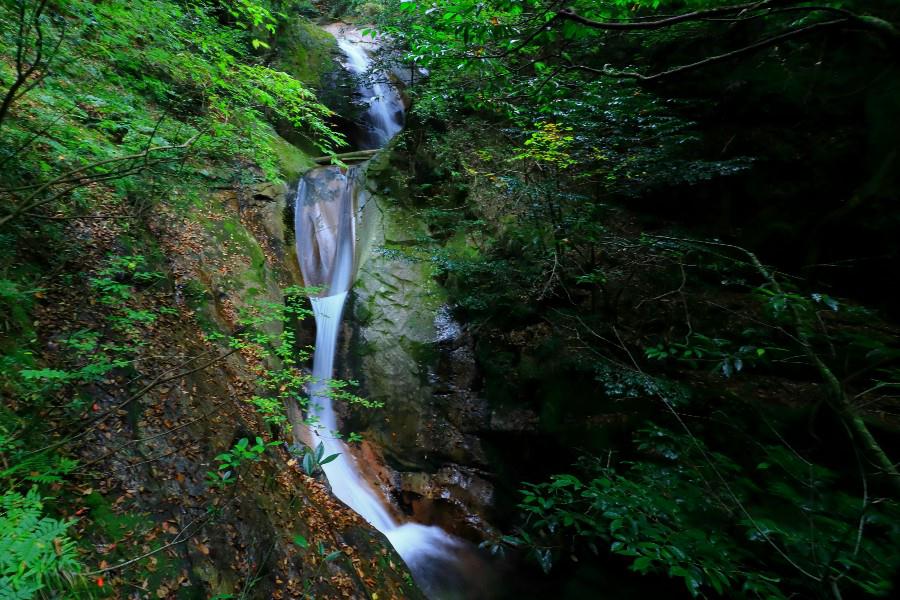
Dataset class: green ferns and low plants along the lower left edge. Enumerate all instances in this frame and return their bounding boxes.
[0,246,184,598]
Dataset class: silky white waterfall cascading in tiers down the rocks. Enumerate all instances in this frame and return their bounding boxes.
[295,25,462,598]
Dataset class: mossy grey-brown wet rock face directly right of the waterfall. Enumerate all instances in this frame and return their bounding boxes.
[322,152,502,540]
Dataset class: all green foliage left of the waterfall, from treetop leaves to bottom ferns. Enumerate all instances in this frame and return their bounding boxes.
[0,0,366,599]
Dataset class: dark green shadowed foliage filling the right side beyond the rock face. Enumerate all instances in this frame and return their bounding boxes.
[386,0,900,598]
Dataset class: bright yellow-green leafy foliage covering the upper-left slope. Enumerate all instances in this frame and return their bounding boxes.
[0,0,341,218]
